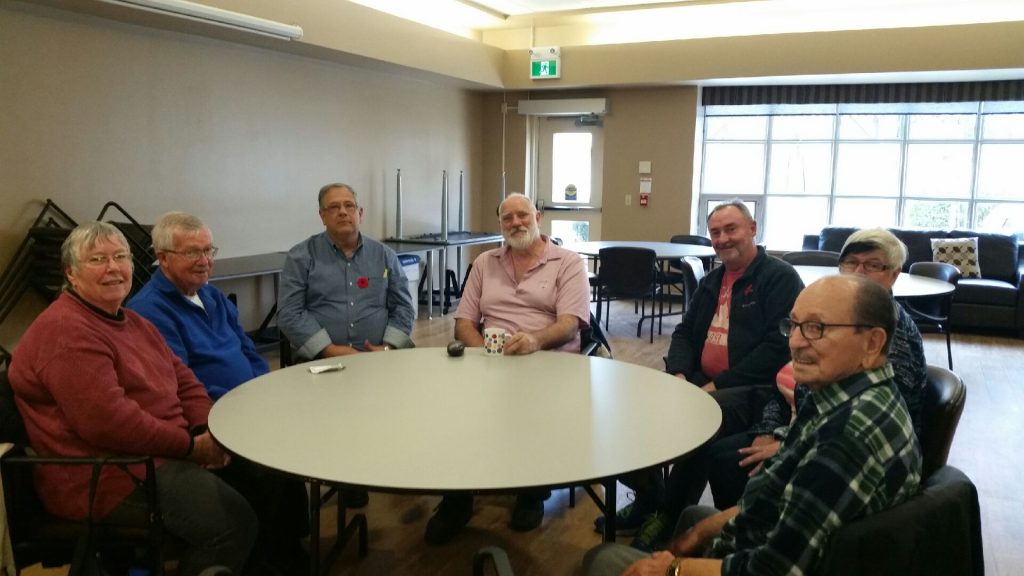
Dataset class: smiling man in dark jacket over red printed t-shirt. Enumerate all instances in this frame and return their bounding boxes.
[598,200,804,534]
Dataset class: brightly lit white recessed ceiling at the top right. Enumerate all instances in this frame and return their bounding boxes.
[350,0,1024,46]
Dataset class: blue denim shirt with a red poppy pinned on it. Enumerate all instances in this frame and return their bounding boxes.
[278,232,415,359]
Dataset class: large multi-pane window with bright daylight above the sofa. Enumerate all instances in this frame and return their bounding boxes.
[697,101,1024,250]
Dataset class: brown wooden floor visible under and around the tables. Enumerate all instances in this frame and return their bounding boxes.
[24,302,1024,576]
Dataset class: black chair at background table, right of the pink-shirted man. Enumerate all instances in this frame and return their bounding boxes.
[597,247,658,343]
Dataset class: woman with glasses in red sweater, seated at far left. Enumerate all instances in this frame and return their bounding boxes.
[9,222,257,576]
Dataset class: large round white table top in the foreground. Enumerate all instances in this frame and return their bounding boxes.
[209,347,722,492]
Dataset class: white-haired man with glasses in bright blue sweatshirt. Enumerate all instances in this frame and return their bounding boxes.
[128,212,308,574]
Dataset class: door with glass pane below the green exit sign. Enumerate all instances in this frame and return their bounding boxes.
[527,116,604,243]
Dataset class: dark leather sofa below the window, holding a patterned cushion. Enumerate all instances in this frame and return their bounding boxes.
[804,227,1024,337]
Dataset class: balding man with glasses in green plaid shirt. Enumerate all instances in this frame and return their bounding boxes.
[584,275,921,576]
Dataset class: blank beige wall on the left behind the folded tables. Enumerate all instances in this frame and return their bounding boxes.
[0,3,482,347]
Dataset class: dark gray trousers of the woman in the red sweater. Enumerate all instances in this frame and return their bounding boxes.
[104,460,258,576]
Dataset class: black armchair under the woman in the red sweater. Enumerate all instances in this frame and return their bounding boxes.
[0,370,164,576]
